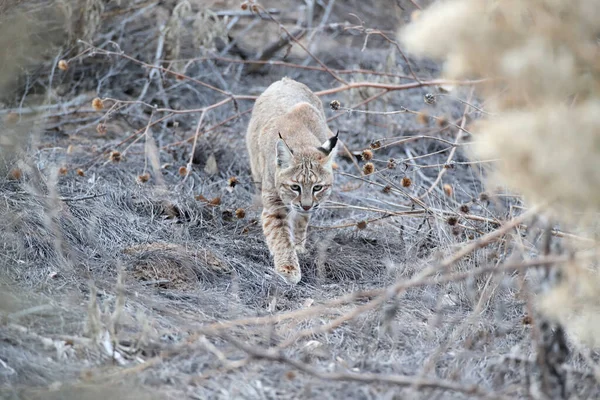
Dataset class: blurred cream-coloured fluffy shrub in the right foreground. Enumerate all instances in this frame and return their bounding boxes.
[400,0,600,346]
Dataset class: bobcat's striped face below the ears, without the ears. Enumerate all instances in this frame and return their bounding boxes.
[277,156,333,214]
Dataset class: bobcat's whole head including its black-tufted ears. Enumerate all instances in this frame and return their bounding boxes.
[275,131,337,214]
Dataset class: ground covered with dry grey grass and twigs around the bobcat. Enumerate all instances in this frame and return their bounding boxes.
[0,0,600,399]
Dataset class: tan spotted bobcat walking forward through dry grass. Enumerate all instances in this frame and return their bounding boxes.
[246,78,338,284]
